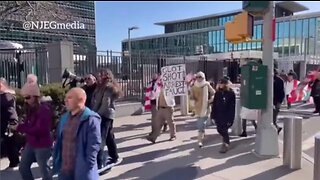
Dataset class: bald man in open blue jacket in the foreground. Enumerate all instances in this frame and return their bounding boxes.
[53,87,101,180]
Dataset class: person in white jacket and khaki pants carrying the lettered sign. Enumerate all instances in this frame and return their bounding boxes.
[147,79,176,143]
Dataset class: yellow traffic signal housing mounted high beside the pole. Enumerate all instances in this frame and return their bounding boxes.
[225,11,254,43]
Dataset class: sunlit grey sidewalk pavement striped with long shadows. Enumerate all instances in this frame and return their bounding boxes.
[0,114,313,180]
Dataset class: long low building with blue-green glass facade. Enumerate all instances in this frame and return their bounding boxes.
[122,1,320,61]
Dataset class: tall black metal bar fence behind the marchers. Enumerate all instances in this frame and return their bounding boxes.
[0,49,238,101]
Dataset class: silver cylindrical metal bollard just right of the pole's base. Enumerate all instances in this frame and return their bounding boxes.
[283,116,303,169]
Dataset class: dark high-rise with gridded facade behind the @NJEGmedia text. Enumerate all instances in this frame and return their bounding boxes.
[0,1,96,52]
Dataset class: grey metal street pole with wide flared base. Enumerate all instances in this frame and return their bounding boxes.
[254,1,279,156]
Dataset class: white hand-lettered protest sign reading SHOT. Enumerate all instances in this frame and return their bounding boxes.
[161,64,188,96]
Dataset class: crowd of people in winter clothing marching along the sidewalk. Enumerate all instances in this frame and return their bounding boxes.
[0,69,320,180]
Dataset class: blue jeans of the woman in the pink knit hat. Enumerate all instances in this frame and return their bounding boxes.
[19,144,52,180]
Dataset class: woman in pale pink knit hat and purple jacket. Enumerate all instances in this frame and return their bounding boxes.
[10,74,53,180]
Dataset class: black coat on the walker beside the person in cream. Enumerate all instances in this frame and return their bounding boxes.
[211,89,236,126]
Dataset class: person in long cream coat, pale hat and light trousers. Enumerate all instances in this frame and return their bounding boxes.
[190,71,215,148]
